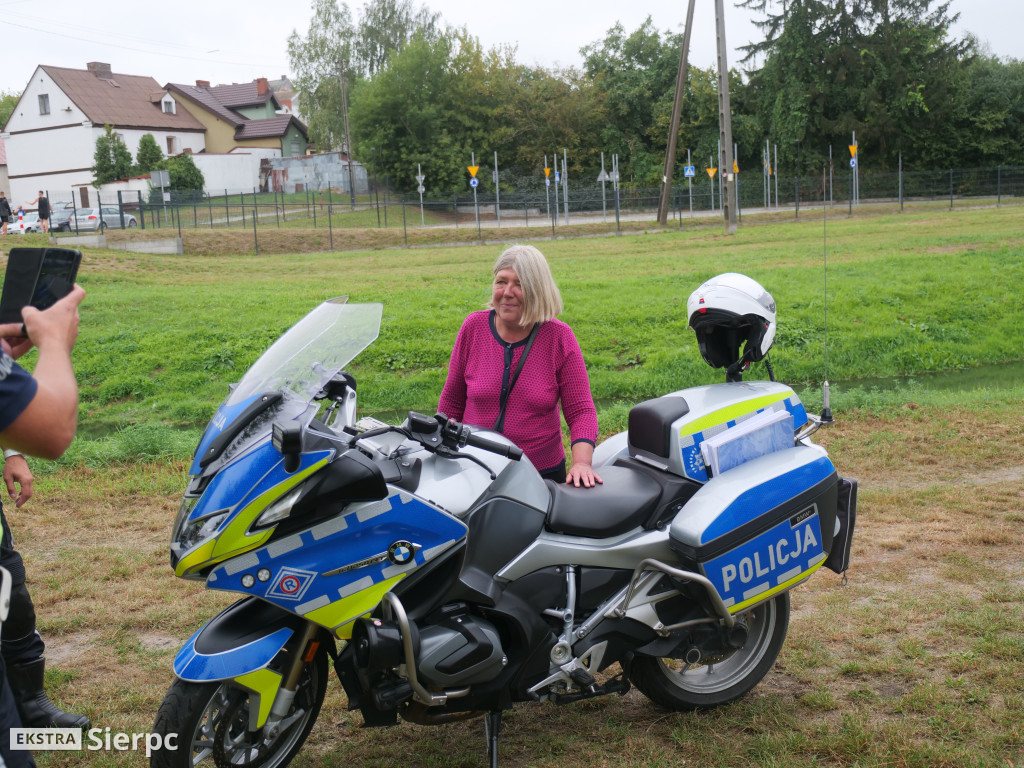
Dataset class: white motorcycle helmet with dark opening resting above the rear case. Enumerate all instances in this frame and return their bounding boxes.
[686,272,775,374]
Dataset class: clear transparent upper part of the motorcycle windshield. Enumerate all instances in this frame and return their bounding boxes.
[224,296,384,407]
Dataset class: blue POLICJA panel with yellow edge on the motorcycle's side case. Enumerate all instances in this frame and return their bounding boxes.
[702,505,825,613]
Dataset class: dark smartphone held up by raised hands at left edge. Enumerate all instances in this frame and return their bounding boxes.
[0,248,82,323]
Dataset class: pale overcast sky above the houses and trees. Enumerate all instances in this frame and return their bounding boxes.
[0,0,1024,93]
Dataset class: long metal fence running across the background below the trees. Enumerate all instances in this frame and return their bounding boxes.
[41,167,1024,237]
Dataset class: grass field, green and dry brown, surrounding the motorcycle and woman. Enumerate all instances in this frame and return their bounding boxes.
[2,204,1024,768]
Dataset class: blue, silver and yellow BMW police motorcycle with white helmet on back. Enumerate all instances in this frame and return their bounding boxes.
[152,274,856,768]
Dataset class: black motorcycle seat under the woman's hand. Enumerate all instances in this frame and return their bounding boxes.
[545,466,662,539]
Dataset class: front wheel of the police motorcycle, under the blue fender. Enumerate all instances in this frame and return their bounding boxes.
[150,653,328,768]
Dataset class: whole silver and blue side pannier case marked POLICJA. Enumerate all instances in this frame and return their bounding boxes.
[669,444,840,613]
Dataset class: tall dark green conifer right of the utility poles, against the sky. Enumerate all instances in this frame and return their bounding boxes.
[739,0,971,168]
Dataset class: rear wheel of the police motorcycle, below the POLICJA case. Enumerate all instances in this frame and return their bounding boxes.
[630,592,790,710]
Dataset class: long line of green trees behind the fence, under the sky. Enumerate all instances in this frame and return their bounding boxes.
[288,0,1024,196]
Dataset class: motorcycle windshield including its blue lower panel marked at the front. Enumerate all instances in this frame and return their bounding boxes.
[188,296,383,476]
